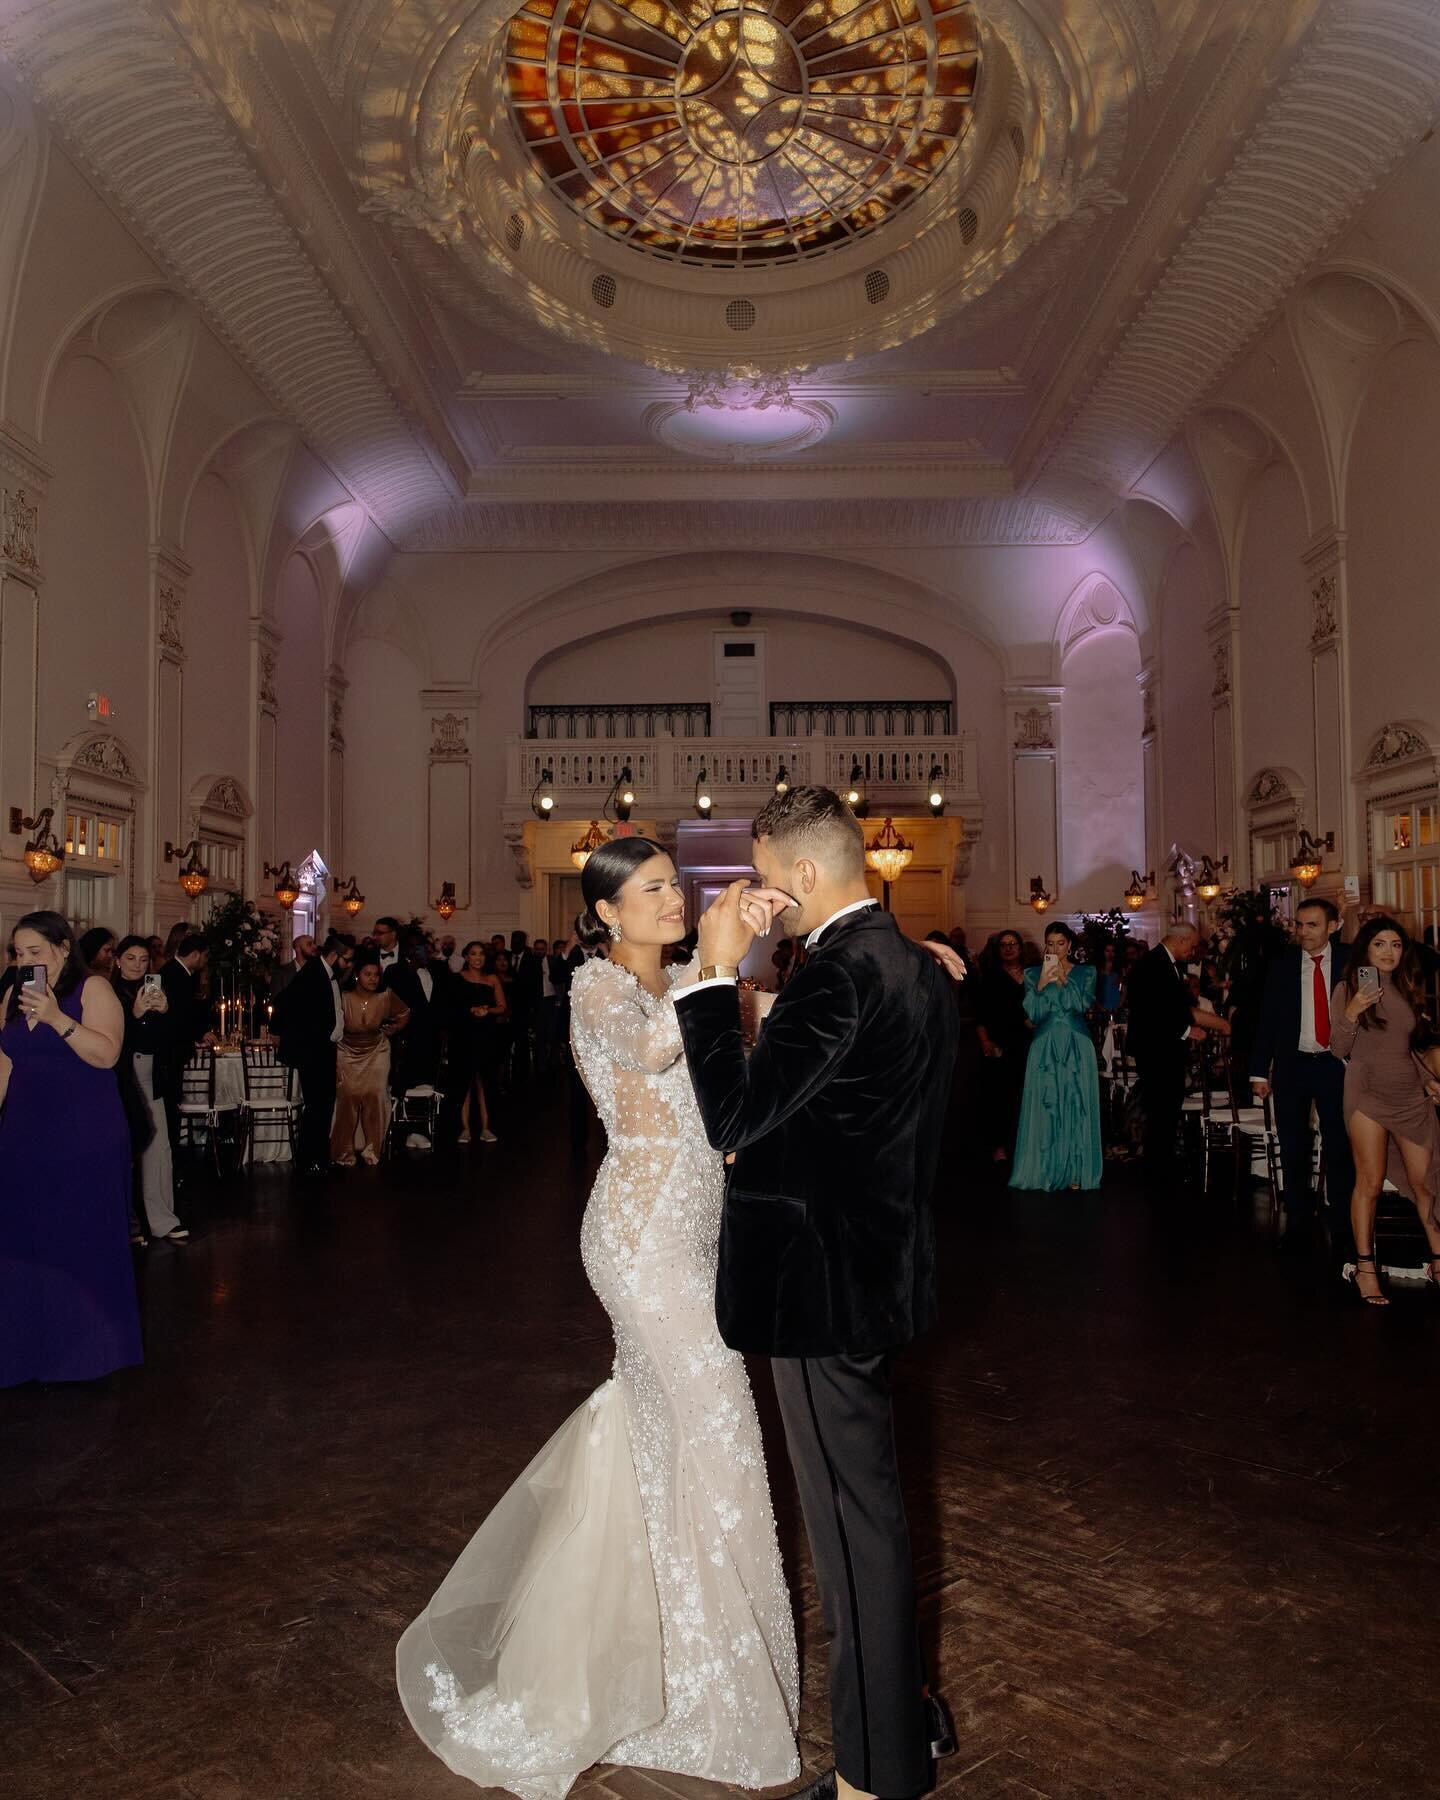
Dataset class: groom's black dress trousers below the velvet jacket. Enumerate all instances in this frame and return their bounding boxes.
[772,1355,931,1800]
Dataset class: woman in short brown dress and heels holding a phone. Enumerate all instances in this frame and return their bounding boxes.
[1330,918,1440,1307]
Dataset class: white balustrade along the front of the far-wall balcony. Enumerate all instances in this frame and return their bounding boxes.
[506,731,979,819]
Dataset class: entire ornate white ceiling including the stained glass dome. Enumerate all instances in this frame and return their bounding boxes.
[0,0,1440,549]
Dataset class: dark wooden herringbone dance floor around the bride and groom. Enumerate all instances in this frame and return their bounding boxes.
[0,1093,1440,1800]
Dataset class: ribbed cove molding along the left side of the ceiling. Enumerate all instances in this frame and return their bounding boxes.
[0,0,455,538]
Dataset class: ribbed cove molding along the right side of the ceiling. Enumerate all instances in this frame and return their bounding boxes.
[1030,0,1440,526]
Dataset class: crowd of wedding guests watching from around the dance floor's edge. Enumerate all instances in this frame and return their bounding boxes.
[0,898,1440,1386]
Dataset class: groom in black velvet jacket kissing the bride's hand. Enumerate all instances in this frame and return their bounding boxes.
[675,787,958,1800]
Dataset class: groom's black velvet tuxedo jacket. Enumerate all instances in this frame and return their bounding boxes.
[675,911,958,1357]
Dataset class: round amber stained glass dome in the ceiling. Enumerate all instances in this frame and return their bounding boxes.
[506,0,979,268]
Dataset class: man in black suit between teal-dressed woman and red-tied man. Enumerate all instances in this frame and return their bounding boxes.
[1125,920,1229,1201]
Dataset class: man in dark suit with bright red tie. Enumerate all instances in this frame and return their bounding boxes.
[1249,900,1355,1255]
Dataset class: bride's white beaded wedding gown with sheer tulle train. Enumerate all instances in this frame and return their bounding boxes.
[396,959,799,1800]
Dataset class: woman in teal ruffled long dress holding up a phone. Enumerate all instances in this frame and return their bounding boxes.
[1010,920,1105,1193]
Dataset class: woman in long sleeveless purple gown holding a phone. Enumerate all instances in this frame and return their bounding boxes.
[0,913,144,1388]
